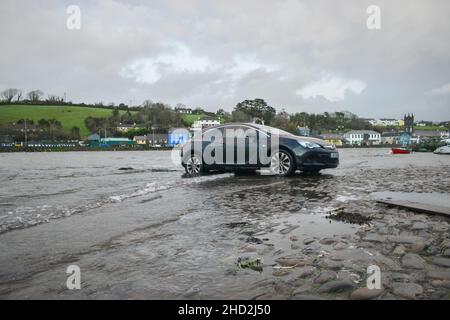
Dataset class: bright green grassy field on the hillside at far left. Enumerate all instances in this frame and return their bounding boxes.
[0,105,132,137]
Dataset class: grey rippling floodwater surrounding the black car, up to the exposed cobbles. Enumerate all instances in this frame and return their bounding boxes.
[0,149,450,299]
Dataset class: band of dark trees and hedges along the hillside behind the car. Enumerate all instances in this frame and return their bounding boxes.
[0,88,373,138]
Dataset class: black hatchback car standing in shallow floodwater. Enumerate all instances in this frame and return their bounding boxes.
[181,123,339,176]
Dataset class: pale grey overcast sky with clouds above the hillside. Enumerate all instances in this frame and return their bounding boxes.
[0,0,450,120]
